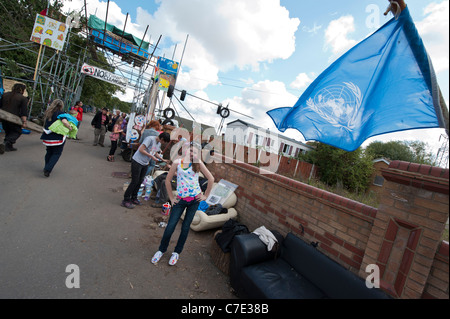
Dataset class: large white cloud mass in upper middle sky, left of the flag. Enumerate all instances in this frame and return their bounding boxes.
[61,0,300,136]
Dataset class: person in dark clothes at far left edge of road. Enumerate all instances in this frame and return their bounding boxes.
[0,83,28,154]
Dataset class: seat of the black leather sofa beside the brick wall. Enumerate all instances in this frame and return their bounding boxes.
[241,258,325,299]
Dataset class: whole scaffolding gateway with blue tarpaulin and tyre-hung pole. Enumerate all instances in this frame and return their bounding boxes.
[0,0,251,132]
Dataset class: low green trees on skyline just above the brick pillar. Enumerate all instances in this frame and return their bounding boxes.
[366,141,433,165]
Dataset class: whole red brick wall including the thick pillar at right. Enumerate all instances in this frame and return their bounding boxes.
[208,159,449,298]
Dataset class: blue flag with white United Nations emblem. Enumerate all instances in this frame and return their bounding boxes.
[267,8,444,151]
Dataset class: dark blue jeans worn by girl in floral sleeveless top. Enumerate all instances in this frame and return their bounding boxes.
[159,199,200,254]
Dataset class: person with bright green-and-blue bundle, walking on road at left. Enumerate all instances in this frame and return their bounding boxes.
[41,100,72,177]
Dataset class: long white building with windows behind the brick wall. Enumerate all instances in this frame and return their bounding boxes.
[225,120,314,157]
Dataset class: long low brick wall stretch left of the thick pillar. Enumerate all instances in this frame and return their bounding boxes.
[208,157,376,273]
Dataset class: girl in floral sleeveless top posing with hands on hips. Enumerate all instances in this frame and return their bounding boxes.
[152,143,214,266]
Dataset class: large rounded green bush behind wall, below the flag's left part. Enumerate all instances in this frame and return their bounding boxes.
[302,143,373,193]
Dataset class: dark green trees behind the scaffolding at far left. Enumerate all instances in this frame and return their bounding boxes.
[0,0,128,111]
